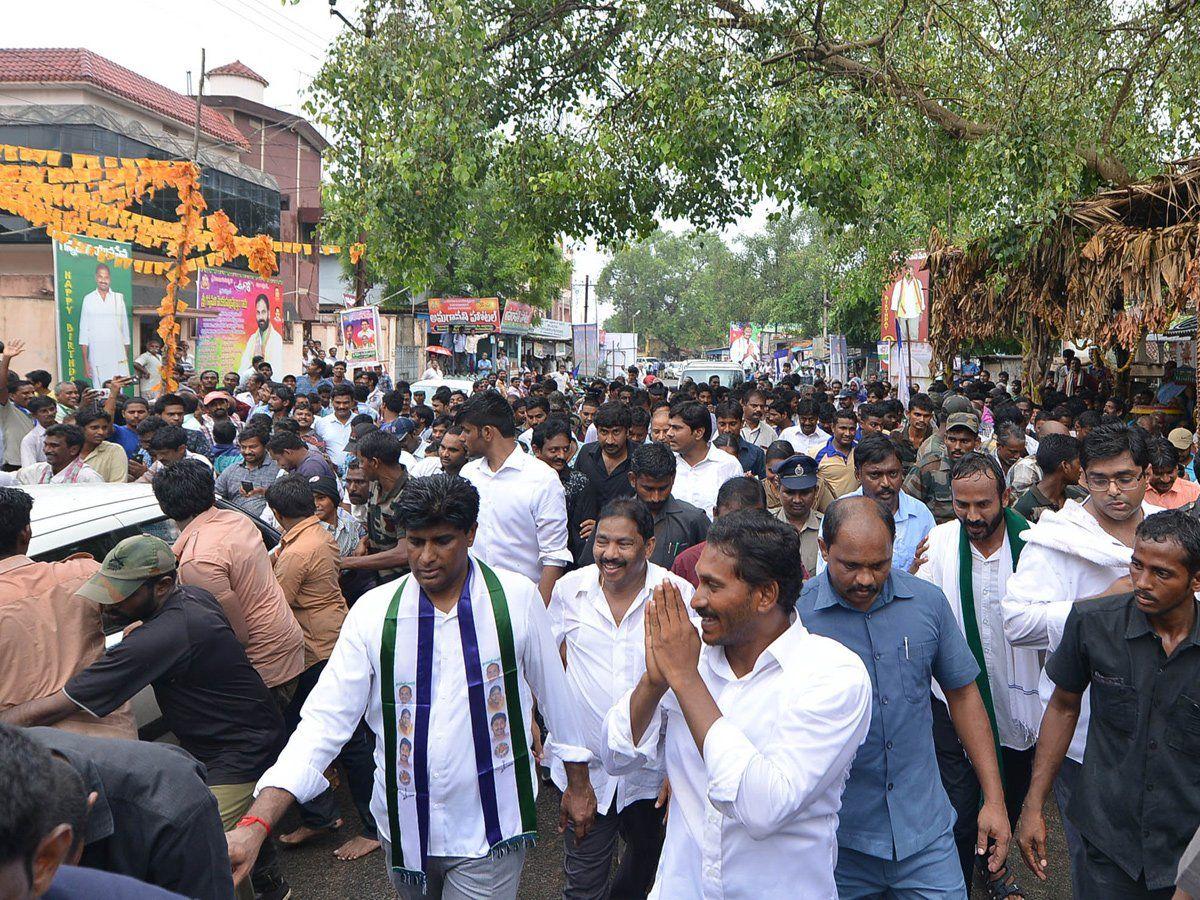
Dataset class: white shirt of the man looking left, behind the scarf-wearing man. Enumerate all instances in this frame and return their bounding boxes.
[458,448,571,582]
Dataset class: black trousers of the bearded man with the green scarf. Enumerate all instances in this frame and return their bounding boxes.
[929,695,1034,893]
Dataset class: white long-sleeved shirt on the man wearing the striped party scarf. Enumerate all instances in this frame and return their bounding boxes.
[254,560,590,859]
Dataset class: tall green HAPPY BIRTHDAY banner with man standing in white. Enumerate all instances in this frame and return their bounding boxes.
[54,235,133,388]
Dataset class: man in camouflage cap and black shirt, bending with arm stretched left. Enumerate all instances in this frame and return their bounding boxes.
[0,535,286,896]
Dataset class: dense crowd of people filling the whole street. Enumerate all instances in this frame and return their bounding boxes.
[0,341,1200,900]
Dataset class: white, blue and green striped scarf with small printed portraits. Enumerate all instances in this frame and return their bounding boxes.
[379,560,538,890]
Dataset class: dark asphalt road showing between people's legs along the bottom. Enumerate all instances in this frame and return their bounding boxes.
[276,786,1070,900]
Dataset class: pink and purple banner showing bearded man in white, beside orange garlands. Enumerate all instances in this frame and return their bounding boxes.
[196,269,283,374]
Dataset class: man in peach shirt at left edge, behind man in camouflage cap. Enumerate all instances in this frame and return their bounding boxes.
[0,487,138,740]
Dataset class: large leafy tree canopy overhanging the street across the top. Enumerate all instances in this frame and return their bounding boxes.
[304,0,1200,324]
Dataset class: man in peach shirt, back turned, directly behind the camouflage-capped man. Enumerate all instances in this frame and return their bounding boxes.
[154,458,305,710]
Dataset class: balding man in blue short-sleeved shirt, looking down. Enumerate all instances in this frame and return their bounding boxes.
[797,497,1010,900]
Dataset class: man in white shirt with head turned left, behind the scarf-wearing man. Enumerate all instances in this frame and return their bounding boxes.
[458,391,573,604]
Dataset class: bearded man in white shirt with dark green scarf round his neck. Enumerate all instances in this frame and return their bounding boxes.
[916,453,1042,886]
